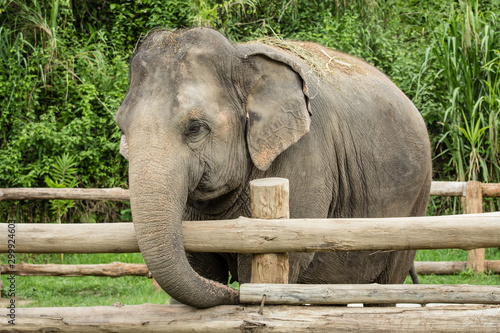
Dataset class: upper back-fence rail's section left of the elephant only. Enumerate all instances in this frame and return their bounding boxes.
[0,188,130,201]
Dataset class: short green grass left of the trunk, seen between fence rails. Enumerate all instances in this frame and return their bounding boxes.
[0,253,170,307]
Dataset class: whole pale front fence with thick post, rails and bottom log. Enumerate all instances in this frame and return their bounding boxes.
[0,179,500,332]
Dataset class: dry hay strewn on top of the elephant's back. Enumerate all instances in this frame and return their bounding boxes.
[253,37,360,78]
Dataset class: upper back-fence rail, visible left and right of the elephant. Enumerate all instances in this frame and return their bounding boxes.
[0,181,500,201]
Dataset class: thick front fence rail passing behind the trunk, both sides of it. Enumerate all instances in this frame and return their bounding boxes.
[0,212,500,253]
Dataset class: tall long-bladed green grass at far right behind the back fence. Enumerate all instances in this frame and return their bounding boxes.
[424,1,500,182]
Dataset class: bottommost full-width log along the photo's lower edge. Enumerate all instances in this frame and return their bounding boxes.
[0,304,500,333]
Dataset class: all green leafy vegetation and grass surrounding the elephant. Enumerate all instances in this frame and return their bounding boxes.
[0,0,500,306]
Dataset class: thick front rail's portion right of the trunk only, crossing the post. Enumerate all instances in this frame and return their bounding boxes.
[183,213,500,253]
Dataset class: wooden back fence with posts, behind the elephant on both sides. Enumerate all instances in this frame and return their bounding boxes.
[0,181,500,276]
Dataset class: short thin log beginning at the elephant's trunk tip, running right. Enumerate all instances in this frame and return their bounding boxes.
[240,283,500,305]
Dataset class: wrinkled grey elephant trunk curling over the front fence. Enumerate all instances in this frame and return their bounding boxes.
[129,147,239,308]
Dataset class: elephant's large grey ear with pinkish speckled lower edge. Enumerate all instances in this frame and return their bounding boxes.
[245,52,311,171]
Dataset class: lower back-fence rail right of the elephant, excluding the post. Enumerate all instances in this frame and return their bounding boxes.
[415,260,500,275]
